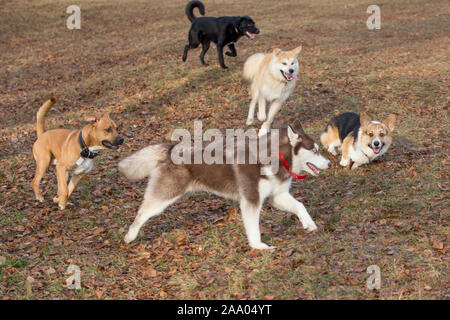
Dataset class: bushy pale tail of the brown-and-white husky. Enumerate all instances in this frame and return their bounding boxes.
[119,144,169,180]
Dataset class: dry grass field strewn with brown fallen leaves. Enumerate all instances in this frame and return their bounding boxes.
[0,0,450,299]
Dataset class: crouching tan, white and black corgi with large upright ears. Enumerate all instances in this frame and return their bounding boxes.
[320,112,396,170]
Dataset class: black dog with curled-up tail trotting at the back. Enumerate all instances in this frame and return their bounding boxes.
[183,1,259,69]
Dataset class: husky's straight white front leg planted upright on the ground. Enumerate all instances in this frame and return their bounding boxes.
[240,199,274,250]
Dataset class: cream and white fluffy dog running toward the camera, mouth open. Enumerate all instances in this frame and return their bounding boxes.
[243,46,302,136]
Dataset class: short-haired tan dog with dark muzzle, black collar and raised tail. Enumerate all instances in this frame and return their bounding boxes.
[31,97,123,210]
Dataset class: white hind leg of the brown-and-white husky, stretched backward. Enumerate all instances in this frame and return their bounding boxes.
[124,193,179,243]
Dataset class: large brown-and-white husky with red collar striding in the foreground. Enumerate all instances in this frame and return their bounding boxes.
[119,121,330,249]
